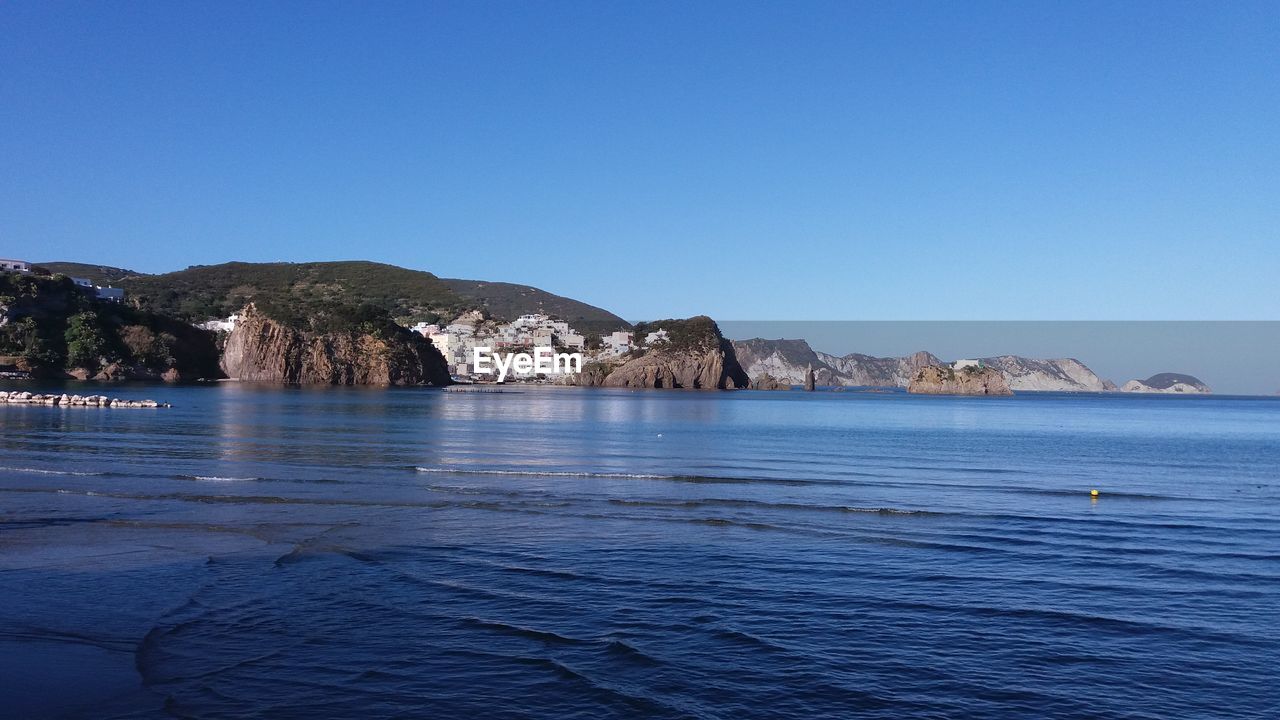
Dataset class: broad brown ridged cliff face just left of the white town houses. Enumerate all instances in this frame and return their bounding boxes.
[221,305,449,386]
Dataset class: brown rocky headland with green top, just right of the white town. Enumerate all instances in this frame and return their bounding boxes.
[577,315,750,389]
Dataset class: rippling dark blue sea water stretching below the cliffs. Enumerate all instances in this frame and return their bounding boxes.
[0,383,1280,719]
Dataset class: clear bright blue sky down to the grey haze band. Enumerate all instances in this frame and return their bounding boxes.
[0,0,1280,320]
